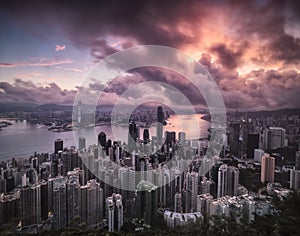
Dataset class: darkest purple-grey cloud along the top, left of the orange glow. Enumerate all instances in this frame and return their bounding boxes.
[2,0,204,46]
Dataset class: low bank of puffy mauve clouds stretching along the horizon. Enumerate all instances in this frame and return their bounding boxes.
[0,59,300,110]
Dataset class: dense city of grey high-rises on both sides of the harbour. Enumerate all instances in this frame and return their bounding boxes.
[0,106,300,235]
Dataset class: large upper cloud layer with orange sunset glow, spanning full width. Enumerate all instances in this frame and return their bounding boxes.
[1,0,300,69]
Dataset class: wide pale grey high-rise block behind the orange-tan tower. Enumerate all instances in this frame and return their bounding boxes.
[263,127,285,150]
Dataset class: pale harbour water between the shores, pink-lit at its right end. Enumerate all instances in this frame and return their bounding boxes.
[0,114,210,160]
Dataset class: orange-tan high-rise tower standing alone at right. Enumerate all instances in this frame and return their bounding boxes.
[260,153,275,183]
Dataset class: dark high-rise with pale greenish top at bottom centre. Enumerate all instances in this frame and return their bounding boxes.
[136,180,157,226]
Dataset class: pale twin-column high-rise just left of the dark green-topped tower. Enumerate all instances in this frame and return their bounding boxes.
[106,194,123,232]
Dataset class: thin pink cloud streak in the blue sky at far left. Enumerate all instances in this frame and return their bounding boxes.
[0,58,72,68]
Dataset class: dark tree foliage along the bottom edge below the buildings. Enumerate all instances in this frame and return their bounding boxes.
[0,191,300,236]
